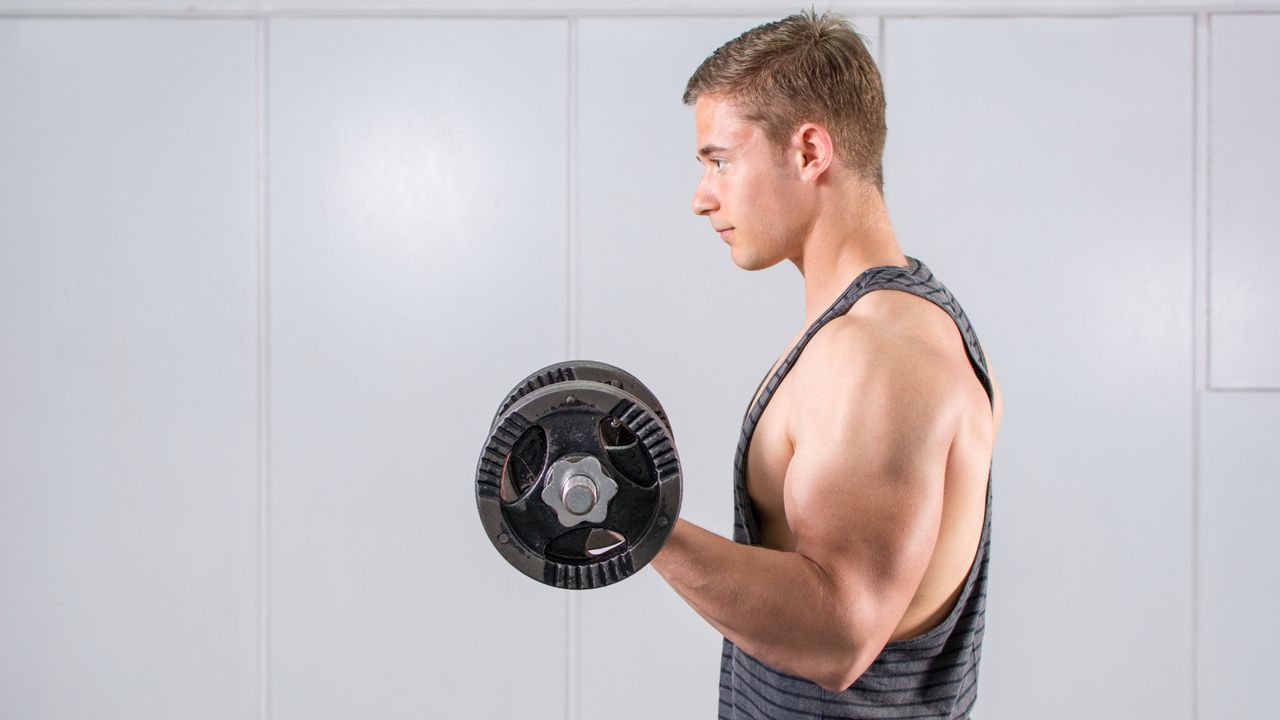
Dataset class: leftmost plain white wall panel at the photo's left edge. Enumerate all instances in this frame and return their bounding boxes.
[0,19,259,719]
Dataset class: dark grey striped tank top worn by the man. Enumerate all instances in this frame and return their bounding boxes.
[719,258,993,720]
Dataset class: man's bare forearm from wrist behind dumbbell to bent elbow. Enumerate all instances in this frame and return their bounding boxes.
[653,520,856,689]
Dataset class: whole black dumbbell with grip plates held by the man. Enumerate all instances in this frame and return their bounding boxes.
[476,360,681,589]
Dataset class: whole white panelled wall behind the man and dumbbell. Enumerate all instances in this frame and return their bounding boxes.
[0,0,1280,720]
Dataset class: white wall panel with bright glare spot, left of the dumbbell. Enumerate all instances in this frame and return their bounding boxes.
[269,19,568,720]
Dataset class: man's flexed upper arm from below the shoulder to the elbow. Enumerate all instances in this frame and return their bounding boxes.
[783,323,956,676]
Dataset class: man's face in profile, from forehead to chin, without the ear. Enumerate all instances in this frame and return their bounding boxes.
[692,95,801,270]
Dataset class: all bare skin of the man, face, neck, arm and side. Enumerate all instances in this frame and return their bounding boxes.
[652,96,1001,691]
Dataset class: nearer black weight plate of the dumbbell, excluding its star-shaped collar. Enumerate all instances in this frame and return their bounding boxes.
[476,380,681,589]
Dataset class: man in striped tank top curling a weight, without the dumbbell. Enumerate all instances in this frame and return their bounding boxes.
[653,13,1001,719]
